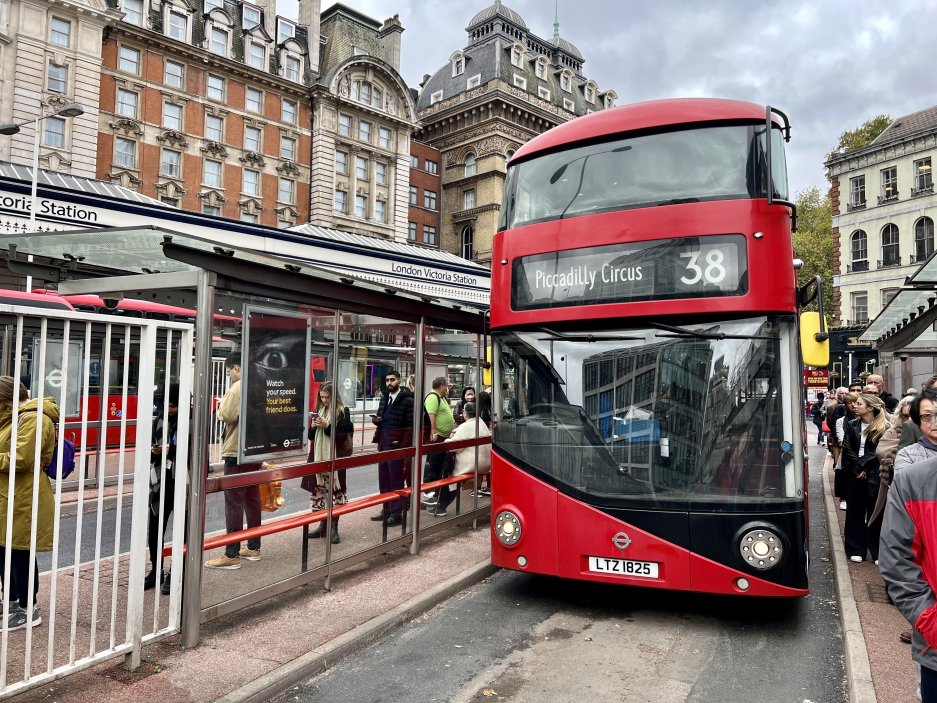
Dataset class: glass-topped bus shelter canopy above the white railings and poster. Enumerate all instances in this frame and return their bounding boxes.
[0,226,485,332]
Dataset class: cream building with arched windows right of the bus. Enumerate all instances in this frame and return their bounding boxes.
[825,107,937,326]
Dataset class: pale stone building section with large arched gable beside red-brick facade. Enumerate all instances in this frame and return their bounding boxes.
[309,3,416,241]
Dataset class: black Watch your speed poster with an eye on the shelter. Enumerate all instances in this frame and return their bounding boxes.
[238,307,311,463]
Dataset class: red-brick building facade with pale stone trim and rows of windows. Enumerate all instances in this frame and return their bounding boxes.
[97,0,318,227]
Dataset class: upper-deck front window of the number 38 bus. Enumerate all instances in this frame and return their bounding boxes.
[499,123,788,230]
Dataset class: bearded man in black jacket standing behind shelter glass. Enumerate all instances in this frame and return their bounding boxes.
[371,371,413,525]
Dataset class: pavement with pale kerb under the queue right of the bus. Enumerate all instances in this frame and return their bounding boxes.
[813,446,918,703]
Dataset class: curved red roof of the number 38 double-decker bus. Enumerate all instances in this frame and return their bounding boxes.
[511,98,780,163]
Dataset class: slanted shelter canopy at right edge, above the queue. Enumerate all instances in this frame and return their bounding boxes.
[859,250,937,356]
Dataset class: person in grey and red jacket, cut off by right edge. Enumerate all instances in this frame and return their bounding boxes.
[879,454,937,703]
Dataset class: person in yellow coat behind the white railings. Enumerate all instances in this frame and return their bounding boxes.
[0,376,59,630]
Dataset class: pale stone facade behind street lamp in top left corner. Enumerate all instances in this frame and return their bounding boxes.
[0,0,120,177]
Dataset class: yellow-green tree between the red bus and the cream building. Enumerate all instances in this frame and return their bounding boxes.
[794,188,833,317]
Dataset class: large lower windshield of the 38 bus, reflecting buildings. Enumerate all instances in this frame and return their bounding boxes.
[493,316,803,506]
